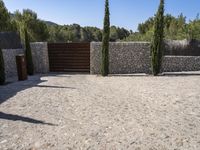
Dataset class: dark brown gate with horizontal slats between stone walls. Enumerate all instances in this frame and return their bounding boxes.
[48,43,90,73]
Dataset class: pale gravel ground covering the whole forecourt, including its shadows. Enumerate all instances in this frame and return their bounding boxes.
[0,74,200,150]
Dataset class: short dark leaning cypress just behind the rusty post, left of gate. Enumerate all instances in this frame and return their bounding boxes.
[24,28,34,75]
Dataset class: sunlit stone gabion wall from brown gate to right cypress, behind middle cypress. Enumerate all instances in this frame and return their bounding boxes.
[90,42,151,74]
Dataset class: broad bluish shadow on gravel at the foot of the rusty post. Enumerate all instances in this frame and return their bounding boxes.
[0,74,75,105]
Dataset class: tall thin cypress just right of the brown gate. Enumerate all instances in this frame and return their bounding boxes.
[101,0,110,76]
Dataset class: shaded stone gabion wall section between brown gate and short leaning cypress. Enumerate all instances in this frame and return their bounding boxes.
[31,42,49,73]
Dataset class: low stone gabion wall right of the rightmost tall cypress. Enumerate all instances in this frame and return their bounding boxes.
[162,56,200,72]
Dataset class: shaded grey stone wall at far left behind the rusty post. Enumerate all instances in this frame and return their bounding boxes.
[2,49,24,78]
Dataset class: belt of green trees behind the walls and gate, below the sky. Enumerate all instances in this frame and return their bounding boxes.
[0,1,200,42]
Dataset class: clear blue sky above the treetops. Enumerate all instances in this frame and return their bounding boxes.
[4,0,200,31]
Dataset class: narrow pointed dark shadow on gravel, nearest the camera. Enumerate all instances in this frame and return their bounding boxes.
[0,112,57,126]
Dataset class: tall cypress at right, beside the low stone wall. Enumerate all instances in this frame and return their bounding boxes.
[151,0,164,76]
